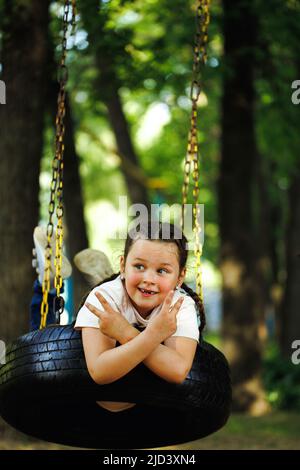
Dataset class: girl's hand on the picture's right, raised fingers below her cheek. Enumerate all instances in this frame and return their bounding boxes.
[147,291,184,343]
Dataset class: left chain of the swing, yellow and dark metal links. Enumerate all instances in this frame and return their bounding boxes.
[40,0,76,329]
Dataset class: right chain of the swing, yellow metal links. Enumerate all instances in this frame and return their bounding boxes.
[181,0,210,302]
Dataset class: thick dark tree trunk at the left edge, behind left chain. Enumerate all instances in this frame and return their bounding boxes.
[0,0,49,341]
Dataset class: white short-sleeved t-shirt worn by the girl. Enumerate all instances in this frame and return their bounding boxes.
[74,276,199,342]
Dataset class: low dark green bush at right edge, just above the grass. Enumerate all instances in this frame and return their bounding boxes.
[263,344,300,410]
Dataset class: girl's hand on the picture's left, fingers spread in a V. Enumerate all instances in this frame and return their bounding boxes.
[85,292,131,342]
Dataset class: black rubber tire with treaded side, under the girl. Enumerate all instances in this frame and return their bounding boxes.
[0,324,231,449]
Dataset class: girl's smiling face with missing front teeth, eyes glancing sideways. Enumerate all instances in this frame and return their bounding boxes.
[120,240,186,317]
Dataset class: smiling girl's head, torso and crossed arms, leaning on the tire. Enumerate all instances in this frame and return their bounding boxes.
[75,222,205,412]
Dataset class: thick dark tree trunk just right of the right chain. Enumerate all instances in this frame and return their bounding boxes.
[218,0,265,414]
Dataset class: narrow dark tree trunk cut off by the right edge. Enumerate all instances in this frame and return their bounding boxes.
[280,172,300,358]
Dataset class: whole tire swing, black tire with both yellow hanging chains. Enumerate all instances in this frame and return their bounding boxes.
[0,0,231,449]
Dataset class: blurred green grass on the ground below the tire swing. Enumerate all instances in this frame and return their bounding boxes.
[0,412,300,450]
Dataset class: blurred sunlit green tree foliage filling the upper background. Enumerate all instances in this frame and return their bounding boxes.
[42,0,300,276]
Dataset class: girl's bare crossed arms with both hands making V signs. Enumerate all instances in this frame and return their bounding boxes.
[83,293,197,384]
